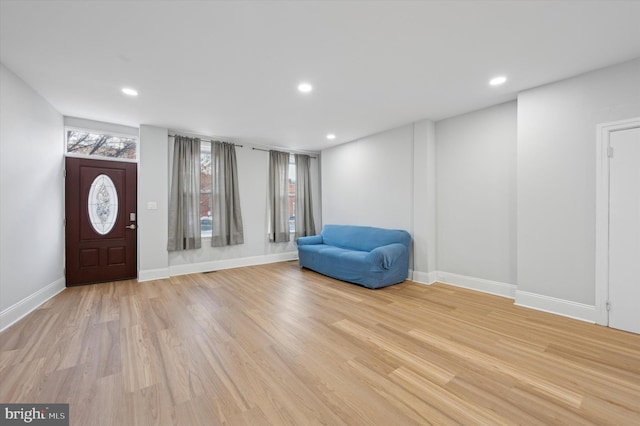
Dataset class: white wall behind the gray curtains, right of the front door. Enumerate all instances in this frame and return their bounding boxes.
[138,126,322,280]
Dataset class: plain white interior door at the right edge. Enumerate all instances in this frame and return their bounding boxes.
[609,127,640,334]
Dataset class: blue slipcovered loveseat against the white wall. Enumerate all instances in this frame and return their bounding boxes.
[297,225,411,288]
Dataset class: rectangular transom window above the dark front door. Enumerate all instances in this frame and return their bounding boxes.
[66,128,138,161]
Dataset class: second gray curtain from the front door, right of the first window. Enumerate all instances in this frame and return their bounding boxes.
[211,141,244,247]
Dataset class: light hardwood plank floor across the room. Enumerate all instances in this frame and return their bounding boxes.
[0,262,640,425]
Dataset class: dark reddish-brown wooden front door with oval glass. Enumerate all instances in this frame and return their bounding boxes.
[65,157,138,286]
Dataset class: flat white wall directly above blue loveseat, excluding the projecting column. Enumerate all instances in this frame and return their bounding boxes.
[321,125,413,232]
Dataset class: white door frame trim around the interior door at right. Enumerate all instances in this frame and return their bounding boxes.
[595,117,640,326]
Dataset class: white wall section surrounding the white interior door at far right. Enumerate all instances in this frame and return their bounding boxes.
[516,59,640,312]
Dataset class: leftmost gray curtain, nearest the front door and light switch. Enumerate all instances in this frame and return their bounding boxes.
[167,136,201,251]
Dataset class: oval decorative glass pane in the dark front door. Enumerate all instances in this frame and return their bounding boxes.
[87,175,118,235]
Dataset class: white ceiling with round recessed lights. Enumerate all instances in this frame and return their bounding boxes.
[0,0,640,151]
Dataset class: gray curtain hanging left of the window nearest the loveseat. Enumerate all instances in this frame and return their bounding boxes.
[267,151,289,243]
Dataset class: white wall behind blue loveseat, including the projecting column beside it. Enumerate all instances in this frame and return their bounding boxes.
[321,120,436,283]
